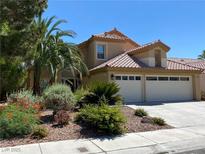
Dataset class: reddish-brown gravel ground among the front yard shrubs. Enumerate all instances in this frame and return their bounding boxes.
[0,106,172,147]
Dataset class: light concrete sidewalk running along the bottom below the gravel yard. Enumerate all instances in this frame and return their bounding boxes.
[0,125,205,154]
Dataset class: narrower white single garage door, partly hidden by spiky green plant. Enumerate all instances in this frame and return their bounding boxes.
[115,75,142,103]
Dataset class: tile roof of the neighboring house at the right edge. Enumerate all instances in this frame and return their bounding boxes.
[170,58,205,73]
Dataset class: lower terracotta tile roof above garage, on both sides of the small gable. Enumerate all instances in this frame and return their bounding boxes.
[90,53,200,71]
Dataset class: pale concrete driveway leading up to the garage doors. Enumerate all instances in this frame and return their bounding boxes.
[128,101,205,128]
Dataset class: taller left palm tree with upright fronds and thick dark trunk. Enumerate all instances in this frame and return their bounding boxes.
[32,15,69,94]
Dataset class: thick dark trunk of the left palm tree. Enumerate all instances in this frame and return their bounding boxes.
[33,62,41,95]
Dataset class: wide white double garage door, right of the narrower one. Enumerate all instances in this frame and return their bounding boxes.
[145,76,193,102]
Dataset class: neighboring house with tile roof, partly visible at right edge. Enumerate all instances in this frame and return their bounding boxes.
[168,58,205,92]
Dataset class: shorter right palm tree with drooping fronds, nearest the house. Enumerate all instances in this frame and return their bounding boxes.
[48,31,88,84]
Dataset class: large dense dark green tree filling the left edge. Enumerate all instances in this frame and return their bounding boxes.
[0,0,47,100]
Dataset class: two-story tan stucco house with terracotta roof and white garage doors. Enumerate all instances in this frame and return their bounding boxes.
[79,29,202,103]
